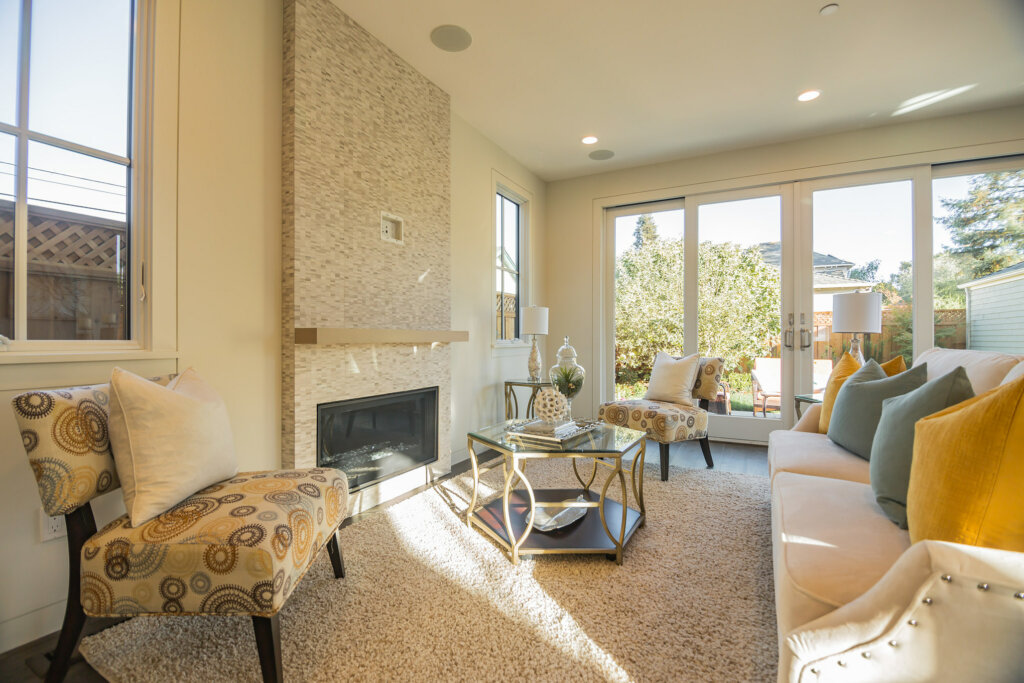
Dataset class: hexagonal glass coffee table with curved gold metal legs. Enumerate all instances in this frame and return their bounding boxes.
[466,420,646,564]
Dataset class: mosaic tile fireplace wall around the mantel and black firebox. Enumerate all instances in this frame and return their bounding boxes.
[282,0,452,485]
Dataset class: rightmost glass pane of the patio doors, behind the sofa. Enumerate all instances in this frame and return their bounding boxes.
[932,169,1024,353]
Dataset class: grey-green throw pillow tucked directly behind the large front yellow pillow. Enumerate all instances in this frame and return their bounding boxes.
[870,367,974,528]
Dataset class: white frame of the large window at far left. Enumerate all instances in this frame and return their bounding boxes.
[0,0,156,352]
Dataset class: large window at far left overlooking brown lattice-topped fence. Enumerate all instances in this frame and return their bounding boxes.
[0,0,142,348]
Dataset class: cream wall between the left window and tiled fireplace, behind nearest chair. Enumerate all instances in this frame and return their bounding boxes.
[0,0,283,652]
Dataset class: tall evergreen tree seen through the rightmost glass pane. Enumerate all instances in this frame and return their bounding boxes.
[940,170,1024,278]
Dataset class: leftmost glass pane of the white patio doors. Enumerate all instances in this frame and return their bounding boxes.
[615,209,684,398]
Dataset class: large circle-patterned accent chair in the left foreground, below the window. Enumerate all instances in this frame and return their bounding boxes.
[12,376,348,681]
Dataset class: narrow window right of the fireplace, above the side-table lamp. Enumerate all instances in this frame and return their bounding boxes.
[495,189,523,342]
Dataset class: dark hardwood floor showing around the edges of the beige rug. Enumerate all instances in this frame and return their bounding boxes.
[0,440,768,683]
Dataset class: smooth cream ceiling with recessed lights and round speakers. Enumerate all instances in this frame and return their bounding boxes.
[333,0,1024,180]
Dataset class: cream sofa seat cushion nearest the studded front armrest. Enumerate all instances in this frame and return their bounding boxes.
[772,472,910,637]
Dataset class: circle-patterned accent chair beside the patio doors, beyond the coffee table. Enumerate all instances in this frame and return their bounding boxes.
[597,358,725,481]
